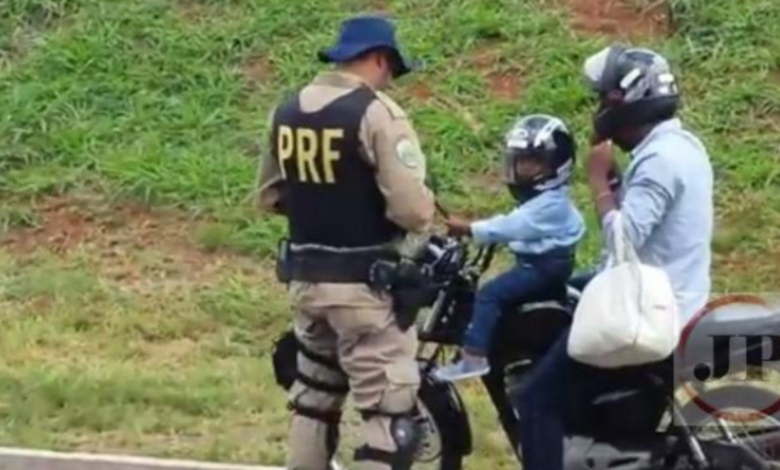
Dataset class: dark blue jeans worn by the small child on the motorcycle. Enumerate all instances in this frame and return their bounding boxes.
[463,249,574,355]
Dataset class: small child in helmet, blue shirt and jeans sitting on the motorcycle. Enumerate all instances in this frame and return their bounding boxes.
[436,114,585,381]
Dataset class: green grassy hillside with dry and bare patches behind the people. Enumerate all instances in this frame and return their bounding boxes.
[0,0,780,468]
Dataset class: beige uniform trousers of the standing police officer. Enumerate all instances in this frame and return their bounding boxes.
[288,282,420,470]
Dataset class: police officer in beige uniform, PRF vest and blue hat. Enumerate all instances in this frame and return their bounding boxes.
[257,12,435,470]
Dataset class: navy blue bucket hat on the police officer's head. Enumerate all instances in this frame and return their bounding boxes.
[318,15,417,78]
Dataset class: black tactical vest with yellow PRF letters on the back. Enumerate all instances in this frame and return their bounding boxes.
[272,87,402,248]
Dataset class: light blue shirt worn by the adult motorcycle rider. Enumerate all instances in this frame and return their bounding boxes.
[603,119,714,322]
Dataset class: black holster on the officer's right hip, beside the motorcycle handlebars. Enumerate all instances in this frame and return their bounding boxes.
[369,260,432,331]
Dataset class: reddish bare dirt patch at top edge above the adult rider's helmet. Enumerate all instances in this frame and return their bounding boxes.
[561,0,672,39]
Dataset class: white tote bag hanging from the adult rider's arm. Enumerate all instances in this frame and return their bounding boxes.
[567,213,680,369]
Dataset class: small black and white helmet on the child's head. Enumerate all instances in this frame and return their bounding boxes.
[503,114,576,202]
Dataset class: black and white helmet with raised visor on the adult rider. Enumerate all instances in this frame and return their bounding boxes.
[584,44,680,139]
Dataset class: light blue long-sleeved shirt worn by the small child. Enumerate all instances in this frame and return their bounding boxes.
[471,186,585,254]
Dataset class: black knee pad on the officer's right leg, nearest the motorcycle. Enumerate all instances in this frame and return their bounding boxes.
[355,412,424,470]
